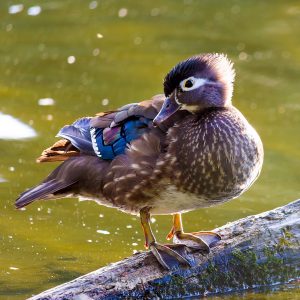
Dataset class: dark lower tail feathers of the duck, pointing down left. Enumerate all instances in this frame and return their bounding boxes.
[15,179,76,208]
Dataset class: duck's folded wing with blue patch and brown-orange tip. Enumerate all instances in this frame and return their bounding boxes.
[37,95,165,162]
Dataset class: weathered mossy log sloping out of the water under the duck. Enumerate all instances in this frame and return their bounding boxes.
[30,200,300,300]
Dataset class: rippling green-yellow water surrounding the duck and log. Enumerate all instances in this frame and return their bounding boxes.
[0,0,300,299]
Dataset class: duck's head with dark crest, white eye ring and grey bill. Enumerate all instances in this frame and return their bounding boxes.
[154,53,235,125]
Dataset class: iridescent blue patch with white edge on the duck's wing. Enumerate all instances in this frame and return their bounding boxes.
[91,117,152,160]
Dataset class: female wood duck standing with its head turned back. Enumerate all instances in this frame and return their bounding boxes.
[16,54,263,269]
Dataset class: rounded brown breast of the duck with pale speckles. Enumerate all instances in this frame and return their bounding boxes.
[167,107,263,207]
